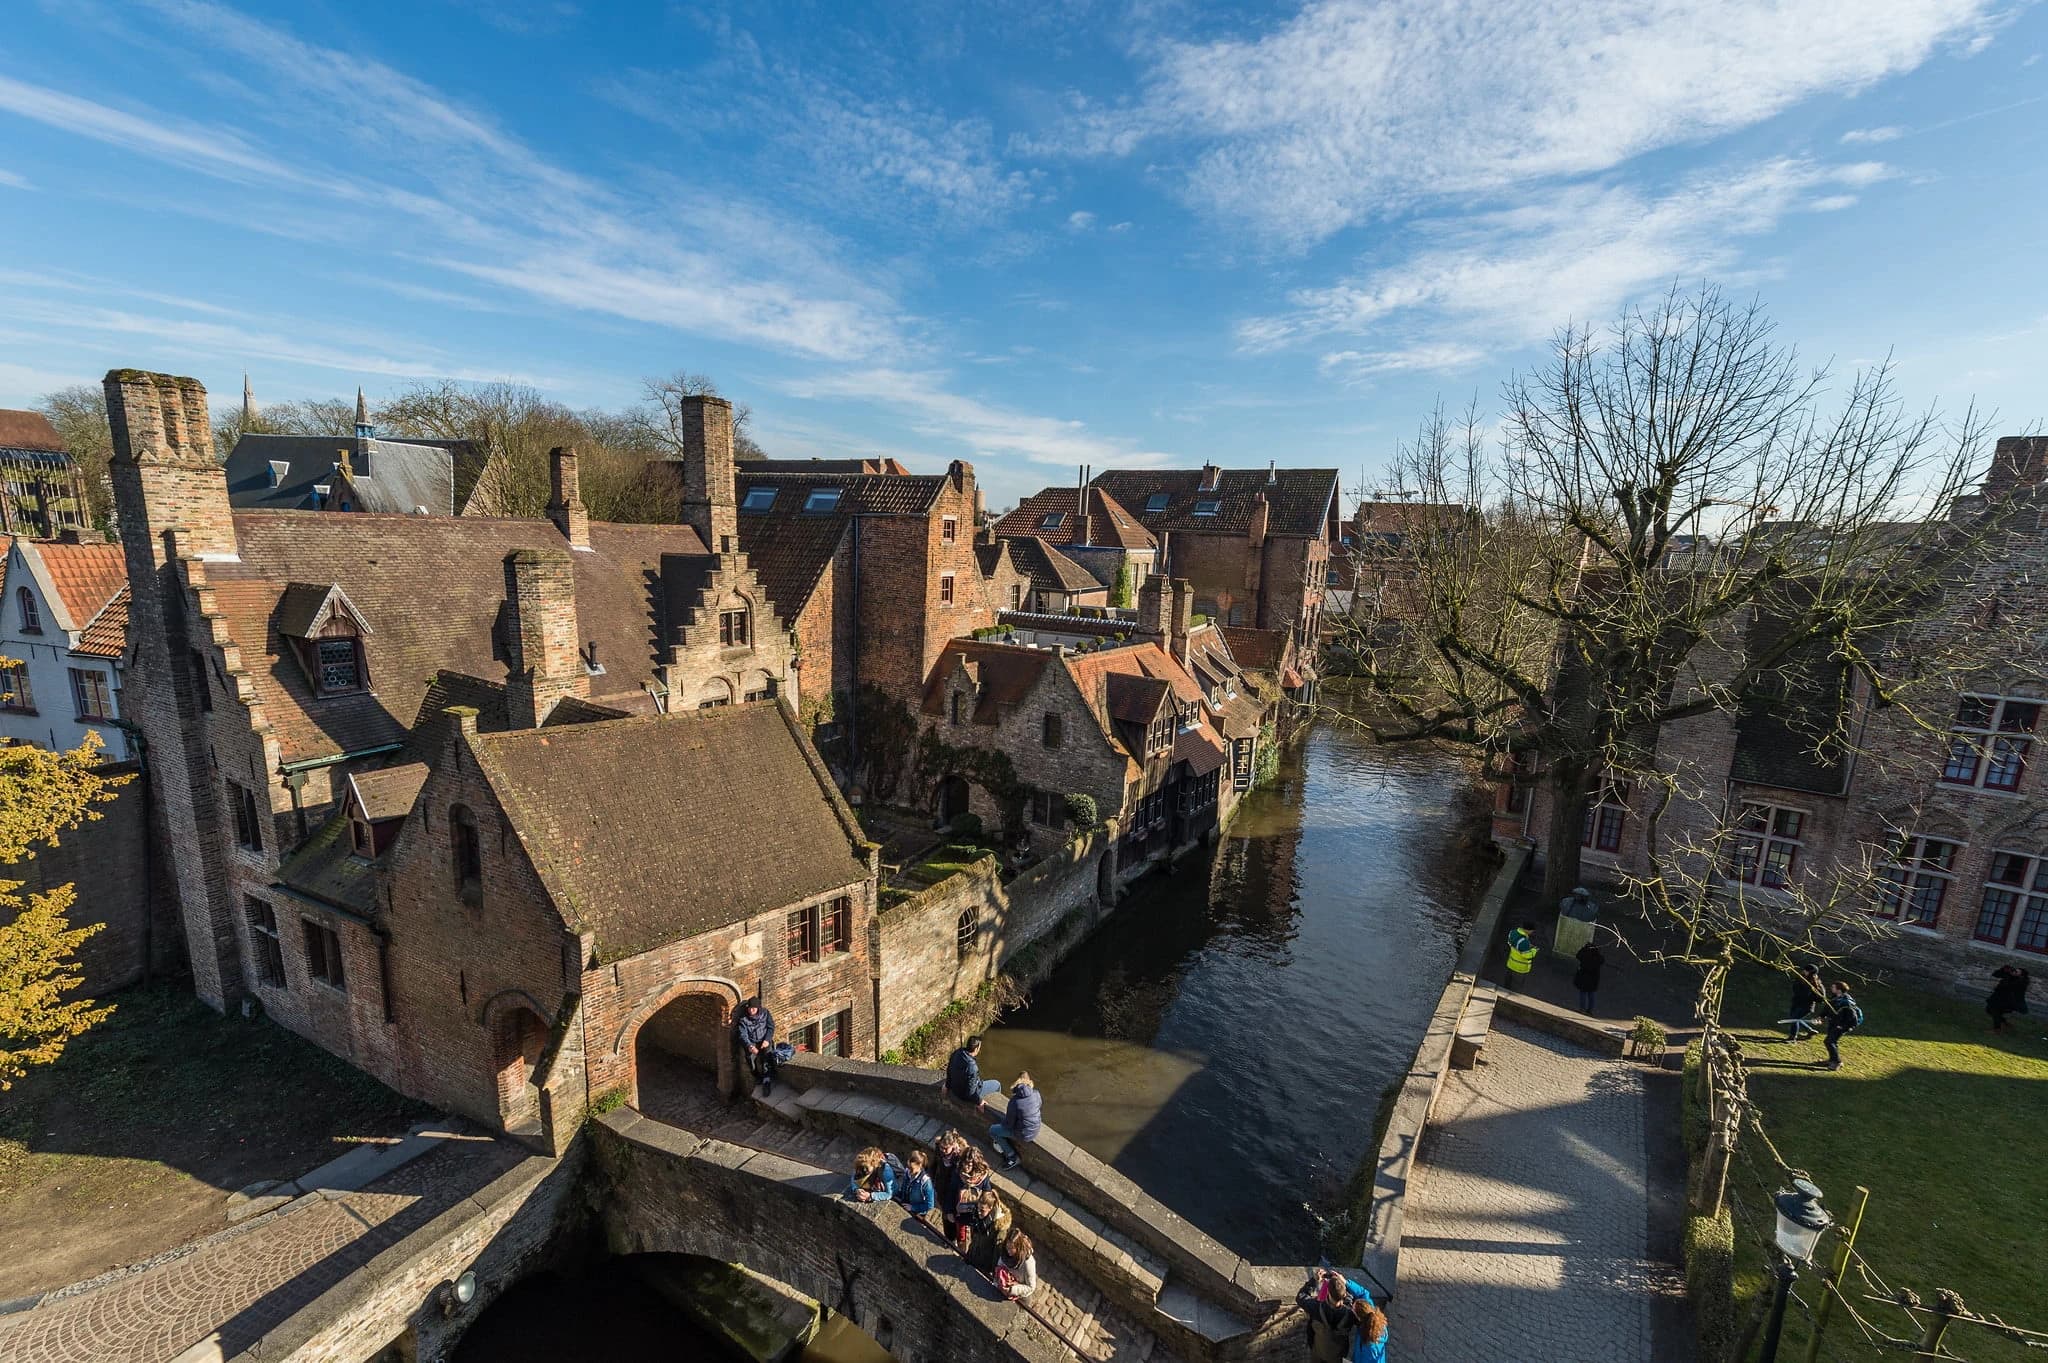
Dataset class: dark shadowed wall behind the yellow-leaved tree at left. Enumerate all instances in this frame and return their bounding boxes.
[8,761,184,999]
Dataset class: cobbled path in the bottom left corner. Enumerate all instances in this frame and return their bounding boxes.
[0,1138,524,1363]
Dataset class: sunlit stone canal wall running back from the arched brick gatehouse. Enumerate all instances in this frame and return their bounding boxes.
[879,829,1112,1050]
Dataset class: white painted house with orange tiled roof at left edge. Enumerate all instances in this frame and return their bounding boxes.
[0,532,133,761]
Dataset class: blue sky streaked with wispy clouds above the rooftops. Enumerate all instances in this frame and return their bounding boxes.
[0,0,2048,505]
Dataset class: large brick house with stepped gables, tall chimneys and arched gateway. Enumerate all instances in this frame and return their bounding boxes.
[106,370,874,1148]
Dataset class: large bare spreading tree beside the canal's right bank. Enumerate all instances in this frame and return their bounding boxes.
[1339,289,1989,908]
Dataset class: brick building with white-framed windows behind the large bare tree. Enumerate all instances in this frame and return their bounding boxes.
[1495,436,2048,993]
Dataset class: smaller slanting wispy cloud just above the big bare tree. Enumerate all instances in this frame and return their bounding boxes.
[1237,160,1888,379]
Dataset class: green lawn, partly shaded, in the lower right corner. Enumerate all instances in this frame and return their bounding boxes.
[1722,968,2048,1363]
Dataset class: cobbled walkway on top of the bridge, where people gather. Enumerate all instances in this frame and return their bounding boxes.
[641,1066,1178,1363]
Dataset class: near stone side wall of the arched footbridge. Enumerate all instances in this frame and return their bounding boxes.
[590,1111,1073,1363]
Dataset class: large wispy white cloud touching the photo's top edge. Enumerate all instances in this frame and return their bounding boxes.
[1016,0,2003,246]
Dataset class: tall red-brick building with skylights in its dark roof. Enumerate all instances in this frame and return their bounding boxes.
[733,448,1032,722]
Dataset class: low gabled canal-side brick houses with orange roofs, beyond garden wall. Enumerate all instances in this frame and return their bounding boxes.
[922,577,1260,870]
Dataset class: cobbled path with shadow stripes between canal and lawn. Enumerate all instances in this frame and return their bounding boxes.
[1389,1023,1690,1363]
